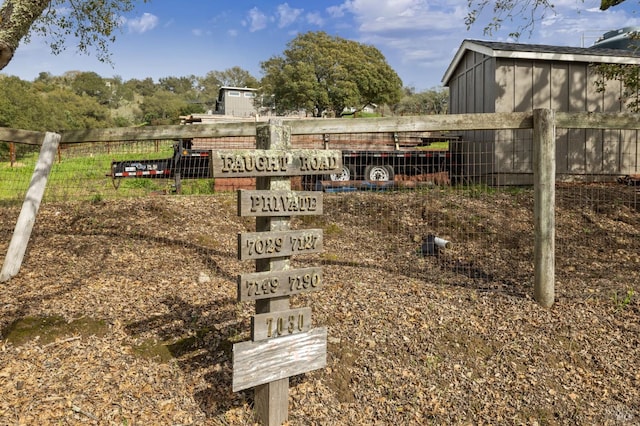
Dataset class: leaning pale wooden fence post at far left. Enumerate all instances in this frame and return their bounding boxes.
[0,132,61,282]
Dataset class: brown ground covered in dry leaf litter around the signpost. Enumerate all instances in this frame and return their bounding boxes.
[0,185,640,425]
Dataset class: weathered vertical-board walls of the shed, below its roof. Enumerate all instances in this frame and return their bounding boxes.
[451,52,640,185]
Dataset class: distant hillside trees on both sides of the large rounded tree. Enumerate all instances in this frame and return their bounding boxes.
[0,60,448,157]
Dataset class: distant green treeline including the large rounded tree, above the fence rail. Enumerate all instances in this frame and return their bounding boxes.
[0,32,448,161]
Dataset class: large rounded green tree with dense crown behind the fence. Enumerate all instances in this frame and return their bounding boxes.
[261,32,402,116]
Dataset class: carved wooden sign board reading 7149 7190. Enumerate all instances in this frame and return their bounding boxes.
[238,266,324,302]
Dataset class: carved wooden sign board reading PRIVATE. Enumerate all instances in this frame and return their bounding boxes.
[238,190,322,216]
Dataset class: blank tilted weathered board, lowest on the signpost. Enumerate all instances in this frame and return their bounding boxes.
[232,327,327,392]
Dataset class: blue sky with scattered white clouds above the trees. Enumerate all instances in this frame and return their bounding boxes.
[0,0,640,91]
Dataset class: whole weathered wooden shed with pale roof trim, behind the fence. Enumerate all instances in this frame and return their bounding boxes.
[442,40,640,185]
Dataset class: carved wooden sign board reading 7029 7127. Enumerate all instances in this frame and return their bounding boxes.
[238,229,322,260]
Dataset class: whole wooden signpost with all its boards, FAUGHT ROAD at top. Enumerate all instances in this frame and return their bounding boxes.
[211,120,342,426]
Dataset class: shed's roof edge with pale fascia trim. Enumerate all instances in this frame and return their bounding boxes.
[442,40,640,86]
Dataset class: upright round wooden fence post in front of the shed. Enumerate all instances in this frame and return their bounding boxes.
[533,109,556,308]
